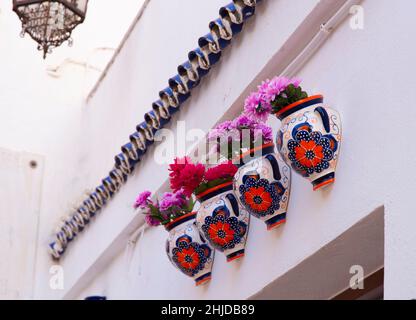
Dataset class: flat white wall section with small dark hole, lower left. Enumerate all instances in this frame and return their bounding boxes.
[0,148,44,300]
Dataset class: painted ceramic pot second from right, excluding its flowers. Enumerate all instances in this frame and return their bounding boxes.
[234,143,291,230]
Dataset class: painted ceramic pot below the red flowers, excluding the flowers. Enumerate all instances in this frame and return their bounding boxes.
[196,181,250,262]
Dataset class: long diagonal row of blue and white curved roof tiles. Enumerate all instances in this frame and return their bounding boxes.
[49,0,261,259]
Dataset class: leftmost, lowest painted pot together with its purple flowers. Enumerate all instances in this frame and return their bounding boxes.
[135,189,214,286]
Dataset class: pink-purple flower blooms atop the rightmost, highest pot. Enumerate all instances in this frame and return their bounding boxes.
[244,77,301,122]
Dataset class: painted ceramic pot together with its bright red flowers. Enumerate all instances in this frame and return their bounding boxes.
[169,158,250,262]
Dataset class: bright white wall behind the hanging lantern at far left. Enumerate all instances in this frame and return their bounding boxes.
[0,0,143,299]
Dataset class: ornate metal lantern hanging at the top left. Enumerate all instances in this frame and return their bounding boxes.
[13,0,88,58]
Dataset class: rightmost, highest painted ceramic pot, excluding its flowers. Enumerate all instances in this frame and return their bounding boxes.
[276,95,341,190]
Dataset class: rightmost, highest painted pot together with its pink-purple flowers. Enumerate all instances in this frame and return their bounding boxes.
[244,77,341,190]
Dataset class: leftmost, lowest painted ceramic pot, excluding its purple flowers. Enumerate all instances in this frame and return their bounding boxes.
[165,212,214,286]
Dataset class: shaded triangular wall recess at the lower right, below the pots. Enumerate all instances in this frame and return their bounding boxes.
[250,207,384,300]
